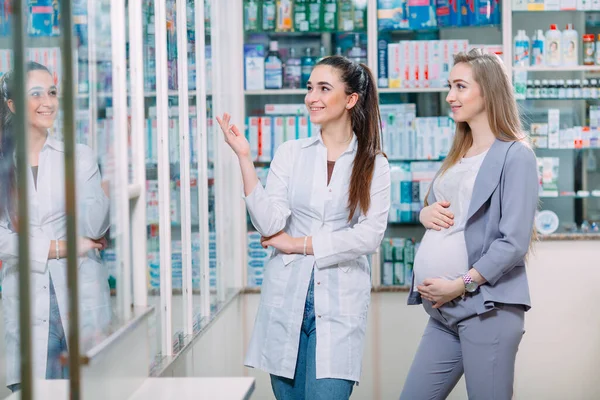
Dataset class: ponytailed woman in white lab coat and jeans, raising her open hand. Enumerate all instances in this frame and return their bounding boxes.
[218,56,390,400]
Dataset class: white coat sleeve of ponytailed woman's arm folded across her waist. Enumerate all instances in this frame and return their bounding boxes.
[312,156,390,268]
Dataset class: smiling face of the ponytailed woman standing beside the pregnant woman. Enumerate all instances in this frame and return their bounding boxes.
[304,65,357,125]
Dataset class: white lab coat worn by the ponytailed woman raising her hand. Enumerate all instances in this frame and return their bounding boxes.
[245,135,390,382]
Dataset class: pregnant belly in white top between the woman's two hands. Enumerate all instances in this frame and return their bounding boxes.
[414,230,469,286]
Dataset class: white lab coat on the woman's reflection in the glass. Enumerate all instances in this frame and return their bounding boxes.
[0,136,111,385]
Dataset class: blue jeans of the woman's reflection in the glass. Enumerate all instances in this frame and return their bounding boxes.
[7,276,69,392]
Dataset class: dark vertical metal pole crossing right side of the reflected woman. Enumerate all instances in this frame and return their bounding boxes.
[60,0,81,400]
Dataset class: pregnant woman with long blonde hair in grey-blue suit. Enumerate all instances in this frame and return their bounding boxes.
[400,49,538,400]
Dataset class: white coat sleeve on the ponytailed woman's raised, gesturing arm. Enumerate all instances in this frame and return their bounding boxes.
[244,141,294,237]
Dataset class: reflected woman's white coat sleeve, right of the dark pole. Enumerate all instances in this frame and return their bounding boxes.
[77,144,110,239]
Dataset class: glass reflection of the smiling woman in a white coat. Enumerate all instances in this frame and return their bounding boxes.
[0,62,111,391]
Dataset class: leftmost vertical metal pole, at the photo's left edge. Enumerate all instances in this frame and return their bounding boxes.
[13,0,33,400]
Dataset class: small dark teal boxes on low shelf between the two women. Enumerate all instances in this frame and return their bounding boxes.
[381,238,418,287]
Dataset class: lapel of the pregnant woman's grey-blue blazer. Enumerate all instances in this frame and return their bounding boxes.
[467,139,515,221]
